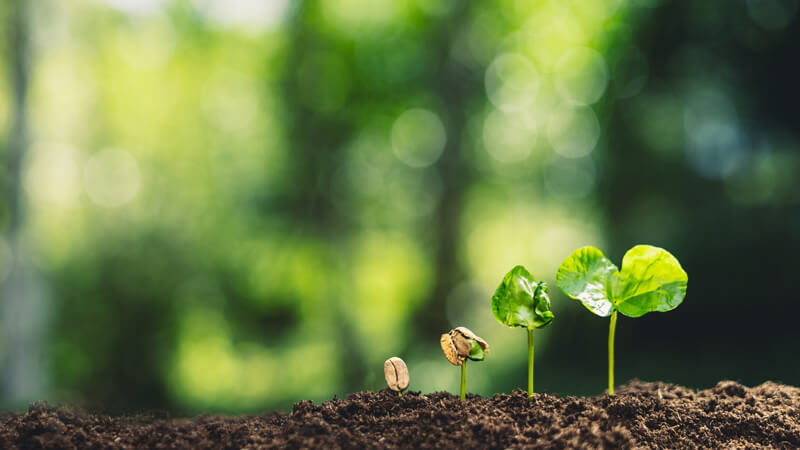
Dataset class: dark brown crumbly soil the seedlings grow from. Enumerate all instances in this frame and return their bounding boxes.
[0,381,800,449]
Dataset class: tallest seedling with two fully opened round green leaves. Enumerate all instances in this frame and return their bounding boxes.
[556,245,689,395]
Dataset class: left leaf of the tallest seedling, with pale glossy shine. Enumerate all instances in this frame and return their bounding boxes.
[556,247,617,317]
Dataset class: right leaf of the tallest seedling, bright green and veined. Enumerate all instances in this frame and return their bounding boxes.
[614,245,689,317]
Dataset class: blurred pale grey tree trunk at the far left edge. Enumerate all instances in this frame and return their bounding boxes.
[0,0,44,406]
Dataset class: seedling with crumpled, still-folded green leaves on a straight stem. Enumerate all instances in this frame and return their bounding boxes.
[492,266,555,400]
